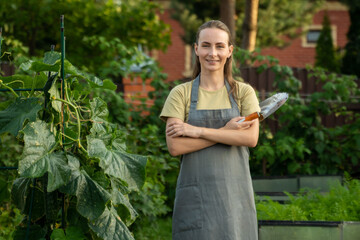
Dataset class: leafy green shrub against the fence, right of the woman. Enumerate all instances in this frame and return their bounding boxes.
[234,49,360,175]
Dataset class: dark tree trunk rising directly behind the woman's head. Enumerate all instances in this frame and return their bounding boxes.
[220,0,236,43]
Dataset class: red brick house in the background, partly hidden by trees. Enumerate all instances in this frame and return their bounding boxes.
[123,0,350,104]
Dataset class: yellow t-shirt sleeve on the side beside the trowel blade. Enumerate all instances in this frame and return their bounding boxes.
[240,84,260,116]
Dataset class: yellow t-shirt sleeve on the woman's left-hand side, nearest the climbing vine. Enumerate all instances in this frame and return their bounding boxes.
[160,84,186,121]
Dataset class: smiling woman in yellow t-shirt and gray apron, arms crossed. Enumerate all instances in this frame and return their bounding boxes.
[160,20,260,240]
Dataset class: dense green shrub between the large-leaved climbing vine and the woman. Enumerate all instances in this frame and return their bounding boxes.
[94,56,179,221]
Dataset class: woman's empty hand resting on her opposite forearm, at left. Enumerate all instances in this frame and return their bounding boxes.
[166,121,202,138]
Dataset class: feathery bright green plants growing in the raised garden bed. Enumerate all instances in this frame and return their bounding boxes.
[256,177,360,221]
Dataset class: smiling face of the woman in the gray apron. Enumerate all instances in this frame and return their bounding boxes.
[195,28,233,72]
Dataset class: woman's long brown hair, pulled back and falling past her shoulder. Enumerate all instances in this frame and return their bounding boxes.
[193,20,238,99]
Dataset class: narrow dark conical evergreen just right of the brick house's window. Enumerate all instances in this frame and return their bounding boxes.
[315,14,340,72]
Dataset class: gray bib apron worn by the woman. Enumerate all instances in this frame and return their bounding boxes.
[172,76,258,240]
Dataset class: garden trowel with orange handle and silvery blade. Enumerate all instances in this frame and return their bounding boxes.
[238,93,289,123]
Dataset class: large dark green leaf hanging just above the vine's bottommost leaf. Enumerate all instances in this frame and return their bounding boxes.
[60,155,110,220]
